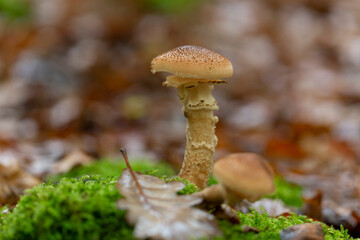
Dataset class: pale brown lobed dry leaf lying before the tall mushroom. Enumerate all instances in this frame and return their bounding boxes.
[118,169,220,240]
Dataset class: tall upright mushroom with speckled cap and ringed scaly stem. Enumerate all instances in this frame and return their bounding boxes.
[151,46,233,189]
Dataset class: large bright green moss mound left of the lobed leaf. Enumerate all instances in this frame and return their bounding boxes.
[0,176,133,240]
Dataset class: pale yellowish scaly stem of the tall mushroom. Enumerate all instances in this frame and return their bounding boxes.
[178,83,218,189]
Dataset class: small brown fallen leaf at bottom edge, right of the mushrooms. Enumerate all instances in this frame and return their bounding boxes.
[280,223,324,240]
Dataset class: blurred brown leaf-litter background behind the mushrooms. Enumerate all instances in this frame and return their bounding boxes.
[0,0,360,235]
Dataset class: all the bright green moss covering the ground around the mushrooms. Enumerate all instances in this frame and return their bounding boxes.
[0,161,351,240]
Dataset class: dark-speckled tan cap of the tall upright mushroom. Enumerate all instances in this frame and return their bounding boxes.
[151,45,233,79]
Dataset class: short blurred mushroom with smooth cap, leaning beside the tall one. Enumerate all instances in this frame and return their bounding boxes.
[197,153,275,206]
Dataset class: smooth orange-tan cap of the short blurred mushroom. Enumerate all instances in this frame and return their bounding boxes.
[214,153,275,201]
